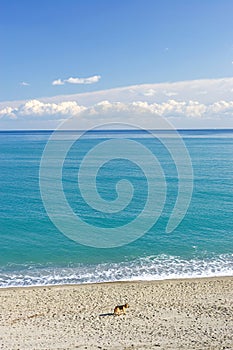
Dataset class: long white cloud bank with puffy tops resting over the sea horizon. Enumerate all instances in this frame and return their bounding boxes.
[0,78,233,130]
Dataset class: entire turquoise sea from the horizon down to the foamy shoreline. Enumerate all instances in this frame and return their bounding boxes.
[0,129,233,288]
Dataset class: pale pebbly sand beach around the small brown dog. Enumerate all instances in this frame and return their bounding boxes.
[0,277,233,350]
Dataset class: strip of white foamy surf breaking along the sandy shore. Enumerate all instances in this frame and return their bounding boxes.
[0,254,233,288]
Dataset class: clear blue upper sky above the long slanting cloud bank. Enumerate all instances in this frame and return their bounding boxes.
[0,0,233,129]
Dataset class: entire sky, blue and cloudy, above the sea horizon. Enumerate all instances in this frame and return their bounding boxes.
[0,0,233,130]
